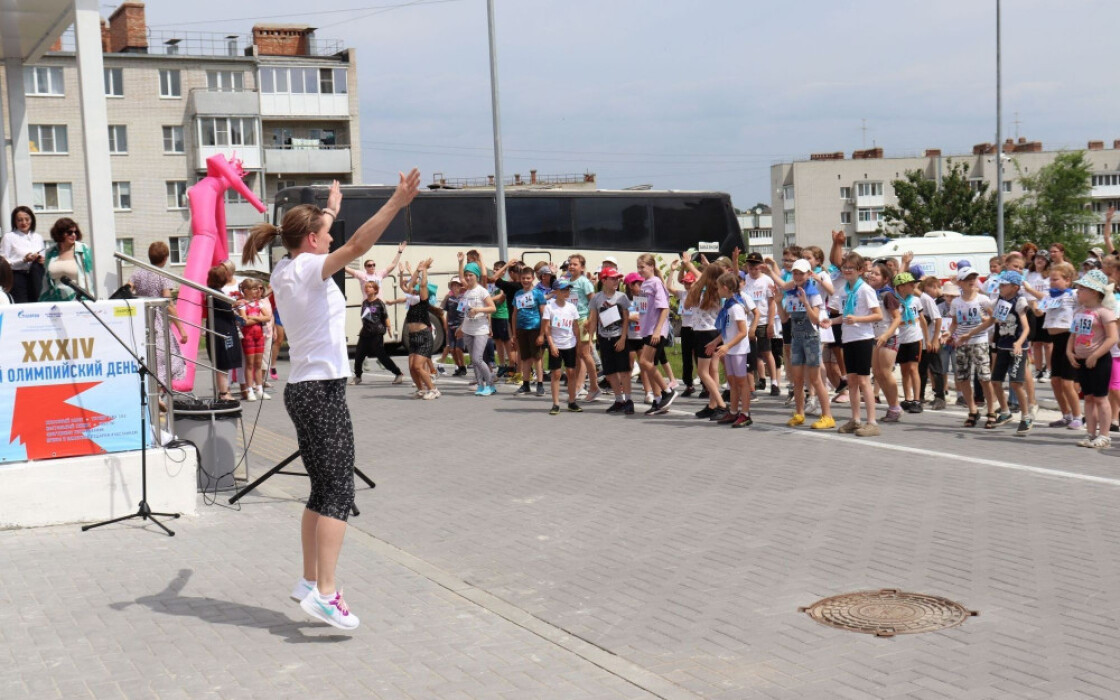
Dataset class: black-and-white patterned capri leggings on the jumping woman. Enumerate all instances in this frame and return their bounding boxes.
[283,379,354,522]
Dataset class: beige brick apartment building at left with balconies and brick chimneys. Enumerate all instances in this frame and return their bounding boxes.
[0,2,361,267]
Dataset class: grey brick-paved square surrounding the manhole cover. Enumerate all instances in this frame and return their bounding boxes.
[0,365,1120,698]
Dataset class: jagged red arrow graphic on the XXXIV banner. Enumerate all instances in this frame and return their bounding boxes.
[9,382,112,459]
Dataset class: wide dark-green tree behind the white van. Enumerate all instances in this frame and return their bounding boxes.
[883,159,1006,236]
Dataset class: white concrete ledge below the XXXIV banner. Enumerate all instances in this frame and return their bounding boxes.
[0,448,198,528]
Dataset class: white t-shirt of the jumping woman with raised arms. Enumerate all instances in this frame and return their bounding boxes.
[271,253,351,383]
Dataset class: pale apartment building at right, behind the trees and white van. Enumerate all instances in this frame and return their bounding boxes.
[771,138,1120,250]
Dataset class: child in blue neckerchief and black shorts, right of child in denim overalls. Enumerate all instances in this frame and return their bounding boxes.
[837,253,883,437]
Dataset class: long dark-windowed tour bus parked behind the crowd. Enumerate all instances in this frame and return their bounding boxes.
[272,186,745,354]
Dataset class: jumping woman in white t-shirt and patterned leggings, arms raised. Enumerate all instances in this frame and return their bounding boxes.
[242,169,420,629]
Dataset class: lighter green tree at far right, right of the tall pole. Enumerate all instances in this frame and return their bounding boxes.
[1007,151,1096,264]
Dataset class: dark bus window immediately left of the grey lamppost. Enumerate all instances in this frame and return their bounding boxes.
[409,195,497,245]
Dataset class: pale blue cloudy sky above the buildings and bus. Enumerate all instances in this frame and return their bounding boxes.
[148,0,1120,208]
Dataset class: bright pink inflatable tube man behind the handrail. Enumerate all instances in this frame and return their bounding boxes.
[171,153,264,391]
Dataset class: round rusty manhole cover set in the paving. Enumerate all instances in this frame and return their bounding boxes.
[797,588,980,637]
